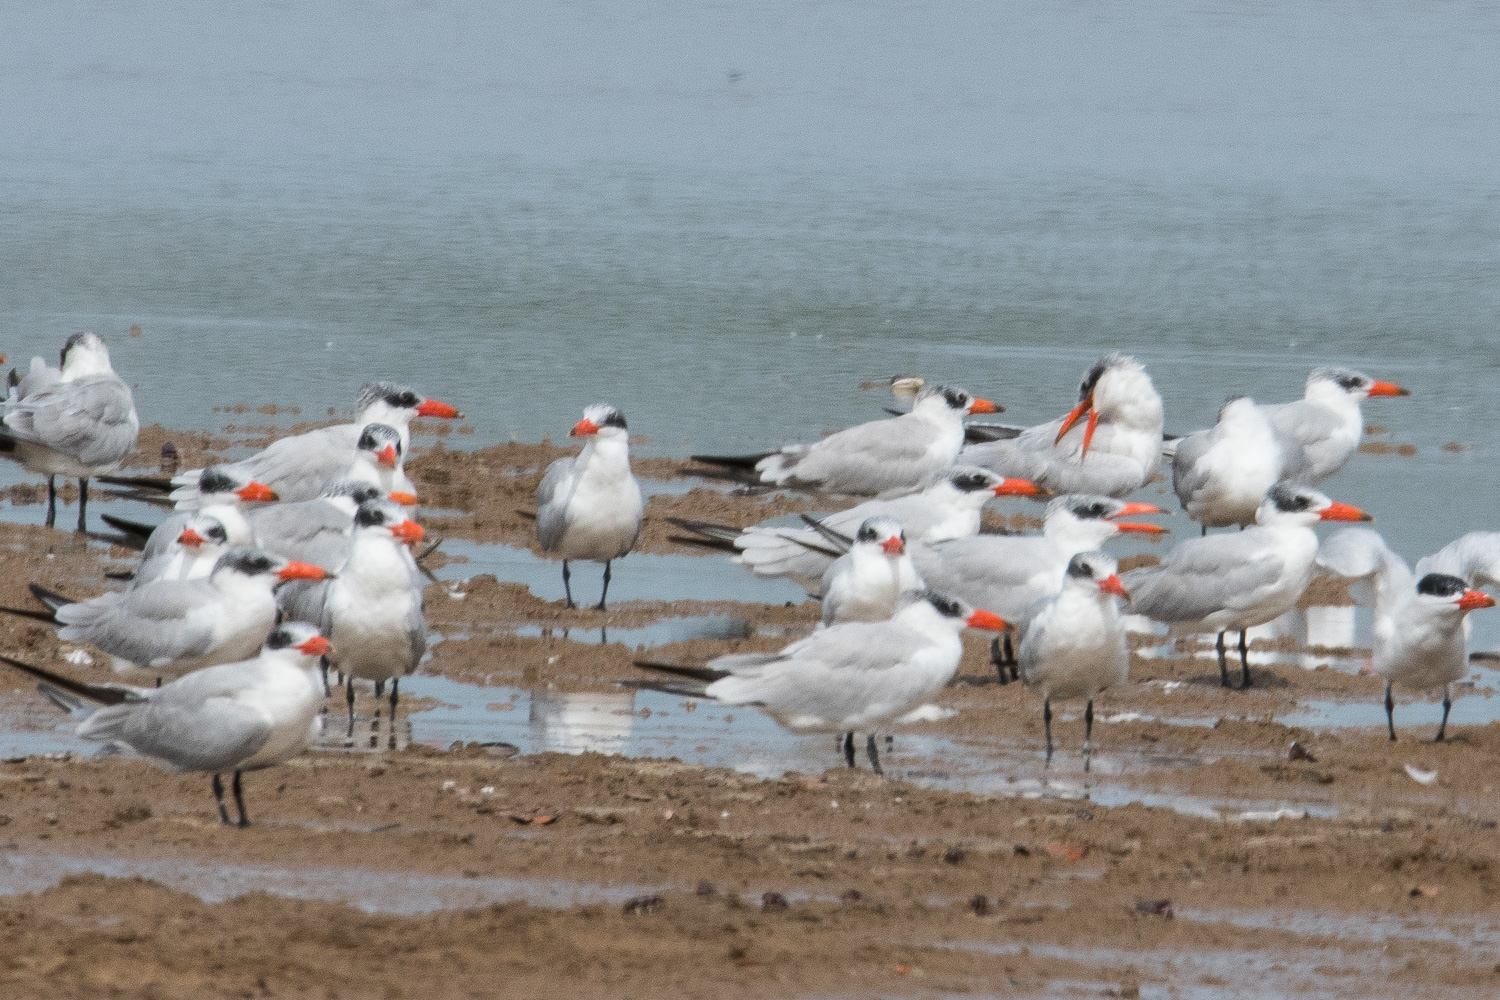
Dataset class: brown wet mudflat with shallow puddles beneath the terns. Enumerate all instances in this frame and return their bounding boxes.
[0,435,1500,997]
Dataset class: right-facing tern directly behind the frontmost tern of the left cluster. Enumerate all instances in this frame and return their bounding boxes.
[6,549,327,675]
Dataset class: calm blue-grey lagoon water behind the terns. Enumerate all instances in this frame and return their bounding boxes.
[0,0,1500,578]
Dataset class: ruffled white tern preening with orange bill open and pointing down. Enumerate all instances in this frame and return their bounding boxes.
[959,354,1163,496]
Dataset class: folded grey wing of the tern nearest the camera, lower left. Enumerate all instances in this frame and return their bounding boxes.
[78,696,272,774]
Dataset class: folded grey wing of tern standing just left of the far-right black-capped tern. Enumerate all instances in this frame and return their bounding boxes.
[1124,534,1283,622]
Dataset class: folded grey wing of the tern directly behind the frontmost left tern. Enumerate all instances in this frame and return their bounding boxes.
[57,580,221,667]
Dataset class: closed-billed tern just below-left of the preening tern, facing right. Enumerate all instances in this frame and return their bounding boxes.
[672,465,1044,597]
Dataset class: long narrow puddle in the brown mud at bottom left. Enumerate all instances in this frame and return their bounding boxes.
[0,853,659,916]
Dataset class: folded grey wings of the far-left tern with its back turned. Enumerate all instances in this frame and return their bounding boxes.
[8,373,141,466]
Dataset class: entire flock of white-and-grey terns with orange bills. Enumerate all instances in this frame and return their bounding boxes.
[0,333,1500,825]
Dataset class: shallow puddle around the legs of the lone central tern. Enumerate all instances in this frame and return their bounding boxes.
[437,538,807,604]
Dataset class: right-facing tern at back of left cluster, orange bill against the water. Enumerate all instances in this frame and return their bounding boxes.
[164,382,462,505]
